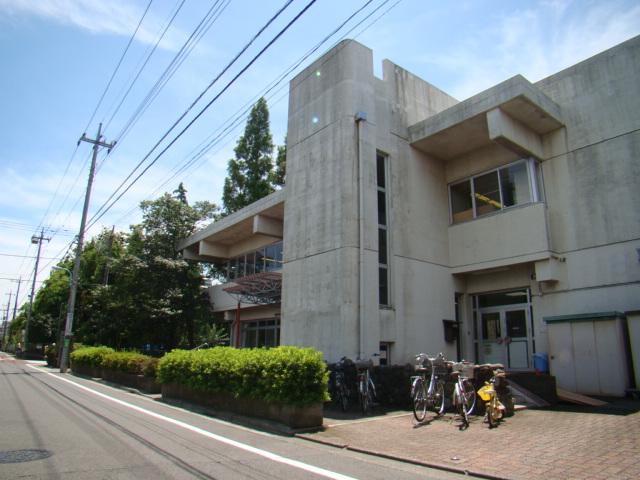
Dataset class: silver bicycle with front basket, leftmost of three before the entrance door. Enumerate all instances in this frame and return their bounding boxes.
[411,353,446,422]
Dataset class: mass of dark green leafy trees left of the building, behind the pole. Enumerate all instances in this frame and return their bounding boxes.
[30,184,218,349]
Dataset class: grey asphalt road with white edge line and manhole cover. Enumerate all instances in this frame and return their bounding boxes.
[0,353,469,480]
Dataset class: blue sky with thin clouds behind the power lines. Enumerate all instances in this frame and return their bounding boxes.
[0,0,640,308]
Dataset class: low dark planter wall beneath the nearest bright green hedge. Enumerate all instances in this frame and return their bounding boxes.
[162,383,323,428]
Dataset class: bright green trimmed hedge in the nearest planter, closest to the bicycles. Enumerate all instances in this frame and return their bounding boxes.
[158,347,329,406]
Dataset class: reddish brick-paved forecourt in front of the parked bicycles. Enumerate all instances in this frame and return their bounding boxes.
[297,400,640,480]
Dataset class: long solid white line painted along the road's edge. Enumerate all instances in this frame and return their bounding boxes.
[28,365,356,480]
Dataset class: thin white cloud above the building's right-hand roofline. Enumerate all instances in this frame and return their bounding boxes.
[424,1,640,100]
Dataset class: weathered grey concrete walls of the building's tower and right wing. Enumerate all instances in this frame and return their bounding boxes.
[281,39,640,372]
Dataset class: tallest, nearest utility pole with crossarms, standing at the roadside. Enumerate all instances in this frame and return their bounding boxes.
[60,123,116,373]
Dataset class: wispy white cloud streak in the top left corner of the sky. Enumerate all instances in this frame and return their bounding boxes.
[0,0,184,50]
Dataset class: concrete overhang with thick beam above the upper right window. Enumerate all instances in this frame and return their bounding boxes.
[409,75,564,160]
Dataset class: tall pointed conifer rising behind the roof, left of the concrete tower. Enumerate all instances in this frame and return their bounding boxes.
[222,98,274,215]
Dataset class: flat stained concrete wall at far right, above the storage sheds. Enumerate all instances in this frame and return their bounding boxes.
[534,37,640,334]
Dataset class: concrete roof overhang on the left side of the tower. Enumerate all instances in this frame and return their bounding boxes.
[178,189,285,262]
